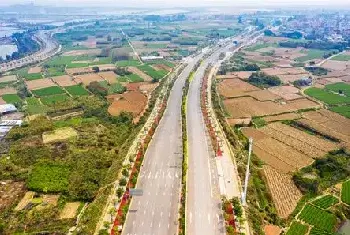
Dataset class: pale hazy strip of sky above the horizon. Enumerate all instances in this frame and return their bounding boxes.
[0,0,350,7]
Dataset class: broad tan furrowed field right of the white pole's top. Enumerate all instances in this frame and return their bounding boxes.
[242,122,337,173]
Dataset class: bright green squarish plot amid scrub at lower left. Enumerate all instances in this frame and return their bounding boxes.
[27,163,69,192]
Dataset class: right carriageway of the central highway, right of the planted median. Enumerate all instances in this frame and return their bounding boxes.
[186,49,225,235]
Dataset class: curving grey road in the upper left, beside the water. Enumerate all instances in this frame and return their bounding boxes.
[0,30,61,72]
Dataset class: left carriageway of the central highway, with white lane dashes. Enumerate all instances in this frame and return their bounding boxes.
[122,54,198,235]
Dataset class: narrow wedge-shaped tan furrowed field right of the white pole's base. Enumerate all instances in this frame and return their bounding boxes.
[263,165,302,218]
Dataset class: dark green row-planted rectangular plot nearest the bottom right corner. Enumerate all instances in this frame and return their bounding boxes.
[298,204,337,232]
